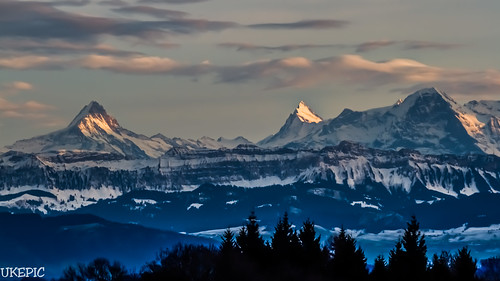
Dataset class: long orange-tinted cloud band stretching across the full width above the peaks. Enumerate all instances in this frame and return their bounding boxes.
[0,49,500,98]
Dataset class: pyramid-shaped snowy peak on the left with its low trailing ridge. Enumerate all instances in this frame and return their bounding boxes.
[6,101,256,159]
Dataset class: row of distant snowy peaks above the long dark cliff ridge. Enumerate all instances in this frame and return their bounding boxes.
[4,88,500,159]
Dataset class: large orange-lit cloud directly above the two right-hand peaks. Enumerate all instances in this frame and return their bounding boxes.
[217,55,500,97]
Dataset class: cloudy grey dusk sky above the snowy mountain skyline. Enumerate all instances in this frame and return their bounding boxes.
[0,0,500,146]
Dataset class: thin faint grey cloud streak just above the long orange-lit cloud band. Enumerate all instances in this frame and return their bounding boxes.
[218,42,347,52]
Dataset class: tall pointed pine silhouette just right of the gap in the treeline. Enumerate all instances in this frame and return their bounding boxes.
[389,216,427,281]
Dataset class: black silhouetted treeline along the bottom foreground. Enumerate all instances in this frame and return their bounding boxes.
[56,212,500,281]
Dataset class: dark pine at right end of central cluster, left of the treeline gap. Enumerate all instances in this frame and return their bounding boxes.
[330,227,368,281]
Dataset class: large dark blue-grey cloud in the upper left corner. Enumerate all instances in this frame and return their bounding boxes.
[0,0,239,41]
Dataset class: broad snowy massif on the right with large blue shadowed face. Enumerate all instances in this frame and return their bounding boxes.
[258,88,500,155]
